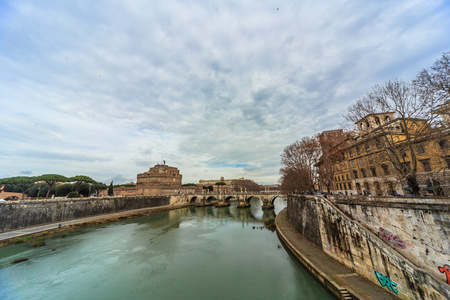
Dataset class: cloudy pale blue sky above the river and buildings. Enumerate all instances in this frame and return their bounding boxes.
[0,0,450,184]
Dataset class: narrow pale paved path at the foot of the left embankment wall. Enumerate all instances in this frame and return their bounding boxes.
[0,204,185,241]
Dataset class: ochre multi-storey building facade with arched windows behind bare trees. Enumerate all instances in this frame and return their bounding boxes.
[333,110,450,196]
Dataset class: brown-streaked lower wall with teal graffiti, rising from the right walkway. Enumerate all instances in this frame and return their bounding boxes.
[287,196,450,299]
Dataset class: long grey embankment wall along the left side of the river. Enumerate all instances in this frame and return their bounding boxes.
[0,196,170,232]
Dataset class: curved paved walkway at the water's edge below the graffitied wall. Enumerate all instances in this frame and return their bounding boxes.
[275,209,399,299]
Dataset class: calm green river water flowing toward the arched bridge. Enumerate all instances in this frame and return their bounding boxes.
[0,199,334,300]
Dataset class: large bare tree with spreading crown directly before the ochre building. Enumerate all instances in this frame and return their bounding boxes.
[344,79,441,195]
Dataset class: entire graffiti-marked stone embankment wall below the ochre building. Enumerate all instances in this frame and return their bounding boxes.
[287,196,450,299]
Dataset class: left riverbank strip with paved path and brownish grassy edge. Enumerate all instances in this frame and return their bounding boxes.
[0,204,189,248]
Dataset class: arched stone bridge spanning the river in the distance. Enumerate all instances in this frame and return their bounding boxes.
[170,192,283,209]
